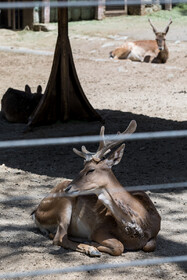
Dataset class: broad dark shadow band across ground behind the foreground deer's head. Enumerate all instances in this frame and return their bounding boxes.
[0,110,187,186]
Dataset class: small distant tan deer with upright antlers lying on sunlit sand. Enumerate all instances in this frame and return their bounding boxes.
[110,19,172,63]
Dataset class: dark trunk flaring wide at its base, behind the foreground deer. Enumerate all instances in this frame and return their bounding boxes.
[28,3,102,127]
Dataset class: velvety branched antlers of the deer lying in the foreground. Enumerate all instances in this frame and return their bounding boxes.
[73,120,137,162]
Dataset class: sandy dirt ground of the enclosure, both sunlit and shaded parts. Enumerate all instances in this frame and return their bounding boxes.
[0,17,187,280]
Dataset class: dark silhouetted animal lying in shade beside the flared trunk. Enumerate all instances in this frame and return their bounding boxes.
[1,85,42,123]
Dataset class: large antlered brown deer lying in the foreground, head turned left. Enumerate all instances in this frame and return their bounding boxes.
[32,121,161,256]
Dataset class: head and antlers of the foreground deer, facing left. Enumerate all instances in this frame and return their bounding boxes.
[64,121,136,196]
